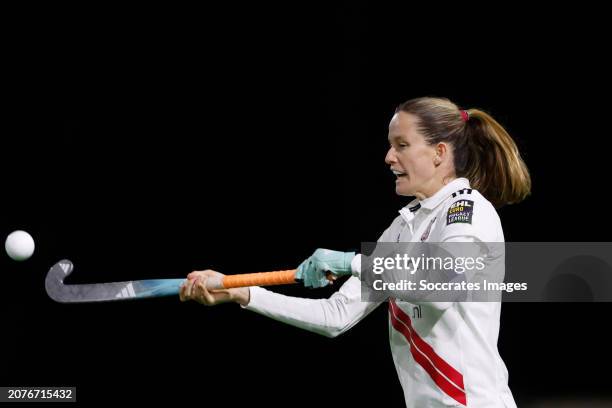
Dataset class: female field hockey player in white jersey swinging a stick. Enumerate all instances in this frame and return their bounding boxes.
[180,98,531,408]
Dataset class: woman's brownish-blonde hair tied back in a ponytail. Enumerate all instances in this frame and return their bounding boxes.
[397,97,531,207]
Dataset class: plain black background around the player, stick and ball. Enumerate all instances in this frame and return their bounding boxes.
[0,4,611,406]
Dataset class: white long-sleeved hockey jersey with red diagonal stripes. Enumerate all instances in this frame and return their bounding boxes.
[246,178,516,408]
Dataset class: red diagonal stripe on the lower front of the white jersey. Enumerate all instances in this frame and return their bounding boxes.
[389,300,467,405]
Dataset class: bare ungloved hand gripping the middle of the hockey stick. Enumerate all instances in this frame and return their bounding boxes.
[179,269,250,306]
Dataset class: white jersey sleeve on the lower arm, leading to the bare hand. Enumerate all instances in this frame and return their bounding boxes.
[244,277,380,337]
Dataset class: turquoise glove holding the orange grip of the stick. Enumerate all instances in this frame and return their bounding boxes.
[295,248,355,288]
